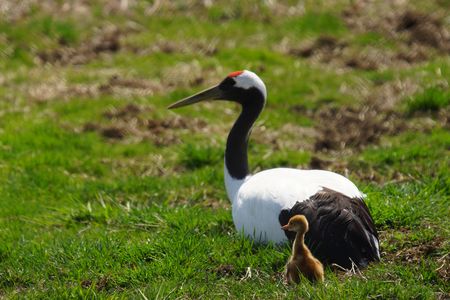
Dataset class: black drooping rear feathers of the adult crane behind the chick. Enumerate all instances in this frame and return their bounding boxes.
[279,188,379,268]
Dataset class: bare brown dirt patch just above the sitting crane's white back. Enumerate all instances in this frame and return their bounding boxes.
[291,76,434,156]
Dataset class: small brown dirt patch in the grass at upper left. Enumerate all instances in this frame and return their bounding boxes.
[38,25,124,65]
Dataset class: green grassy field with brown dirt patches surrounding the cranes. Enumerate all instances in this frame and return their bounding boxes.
[0,0,450,299]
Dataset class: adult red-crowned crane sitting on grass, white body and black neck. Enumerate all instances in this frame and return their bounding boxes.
[169,70,380,268]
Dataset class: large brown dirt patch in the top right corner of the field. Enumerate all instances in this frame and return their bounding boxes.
[286,0,450,70]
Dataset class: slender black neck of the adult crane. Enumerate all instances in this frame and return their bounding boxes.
[225,89,265,179]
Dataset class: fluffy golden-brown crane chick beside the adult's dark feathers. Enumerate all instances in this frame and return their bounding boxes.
[281,215,324,283]
